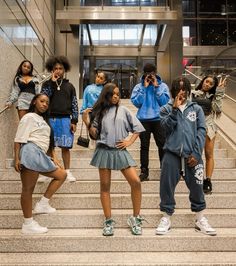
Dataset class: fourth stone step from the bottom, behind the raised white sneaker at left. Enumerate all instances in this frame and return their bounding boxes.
[0,193,236,210]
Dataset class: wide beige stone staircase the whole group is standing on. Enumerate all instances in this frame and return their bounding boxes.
[0,101,236,266]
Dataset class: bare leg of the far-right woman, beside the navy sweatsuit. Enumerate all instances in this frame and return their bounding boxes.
[205,136,215,178]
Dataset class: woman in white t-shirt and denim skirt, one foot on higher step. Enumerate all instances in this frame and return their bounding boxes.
[14,94,66,234]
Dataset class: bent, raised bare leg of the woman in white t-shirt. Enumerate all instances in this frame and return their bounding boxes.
[41,168,66,199]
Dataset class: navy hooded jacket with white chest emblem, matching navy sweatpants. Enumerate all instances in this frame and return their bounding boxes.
[160,101,206,160]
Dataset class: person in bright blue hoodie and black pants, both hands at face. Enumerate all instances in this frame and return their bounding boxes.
[131,63,170,181]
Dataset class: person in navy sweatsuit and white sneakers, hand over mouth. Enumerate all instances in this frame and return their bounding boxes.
[156,77,216,235]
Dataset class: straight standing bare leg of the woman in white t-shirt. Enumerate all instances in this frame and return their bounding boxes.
[20,168,39,218]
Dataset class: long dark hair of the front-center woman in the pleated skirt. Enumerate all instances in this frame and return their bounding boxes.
[90,82,119,133]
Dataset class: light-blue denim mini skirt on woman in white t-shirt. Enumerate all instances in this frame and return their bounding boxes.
[20,142,57,173]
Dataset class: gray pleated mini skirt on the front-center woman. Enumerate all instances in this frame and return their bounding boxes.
[90,144,137,170]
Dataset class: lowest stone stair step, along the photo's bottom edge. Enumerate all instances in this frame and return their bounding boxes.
[0,250,236,266]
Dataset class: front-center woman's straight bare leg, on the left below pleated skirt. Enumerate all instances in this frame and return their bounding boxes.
[99,168,111,219]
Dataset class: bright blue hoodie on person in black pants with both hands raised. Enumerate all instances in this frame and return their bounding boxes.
[130,75,170,122]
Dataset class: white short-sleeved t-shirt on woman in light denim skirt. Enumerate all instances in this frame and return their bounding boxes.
[14,113,51,152]
